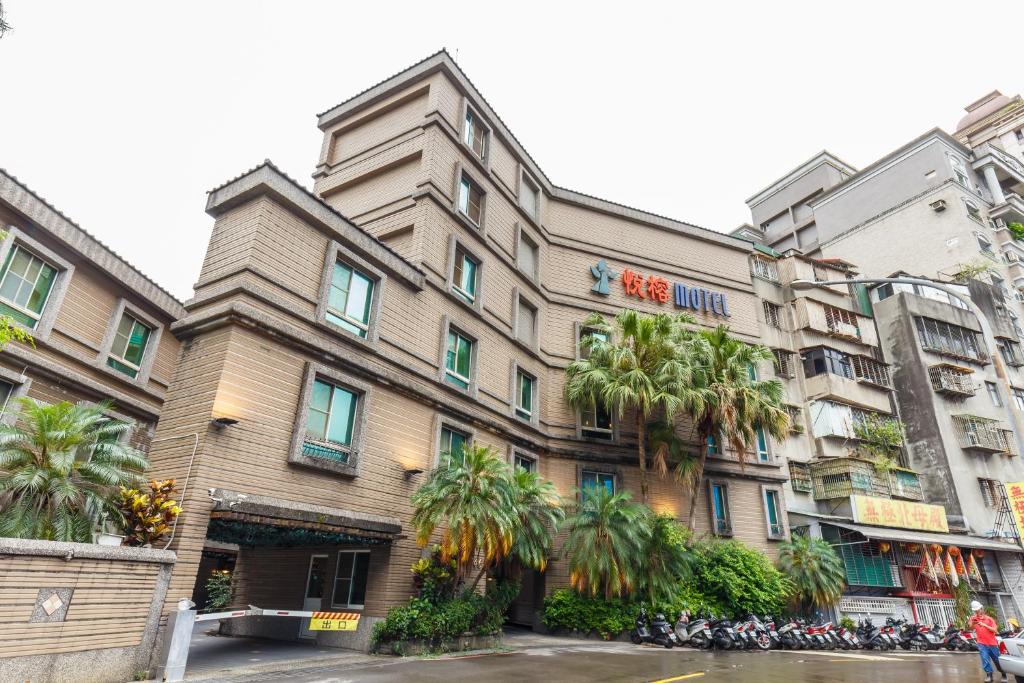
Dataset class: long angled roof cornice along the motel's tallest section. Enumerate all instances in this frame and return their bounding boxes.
[316,50,750,251]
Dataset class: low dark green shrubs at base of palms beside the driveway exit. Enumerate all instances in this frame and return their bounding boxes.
[371,582,519,654]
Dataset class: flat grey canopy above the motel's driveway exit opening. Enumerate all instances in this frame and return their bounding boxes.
[207,488,401,546]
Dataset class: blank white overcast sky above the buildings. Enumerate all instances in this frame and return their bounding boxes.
[0,0,1024,299]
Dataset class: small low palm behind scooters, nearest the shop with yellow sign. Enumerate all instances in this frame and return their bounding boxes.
[778,533,846,611]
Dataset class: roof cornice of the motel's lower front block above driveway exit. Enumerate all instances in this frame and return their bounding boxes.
[206,160,426,290]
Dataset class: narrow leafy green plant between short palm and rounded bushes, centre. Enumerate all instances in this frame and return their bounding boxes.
[638,514,696,602]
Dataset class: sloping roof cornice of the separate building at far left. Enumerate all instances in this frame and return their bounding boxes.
[0,169,185,321]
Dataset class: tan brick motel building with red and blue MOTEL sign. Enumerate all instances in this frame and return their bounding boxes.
[154,52,786,647]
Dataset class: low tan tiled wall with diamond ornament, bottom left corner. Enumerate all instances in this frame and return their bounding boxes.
[0,539,174,683]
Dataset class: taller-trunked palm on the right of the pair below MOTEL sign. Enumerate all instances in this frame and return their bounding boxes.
[682,325,790,529]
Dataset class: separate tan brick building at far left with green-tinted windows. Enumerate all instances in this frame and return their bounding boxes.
[0,170,184,451]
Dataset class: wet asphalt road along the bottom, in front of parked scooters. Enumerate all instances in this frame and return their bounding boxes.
[232,643,999,683]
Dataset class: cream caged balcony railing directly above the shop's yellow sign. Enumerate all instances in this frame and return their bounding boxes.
[810,458,924,501]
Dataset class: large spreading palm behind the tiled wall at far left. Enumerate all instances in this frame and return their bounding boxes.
[0,398,148,543]
